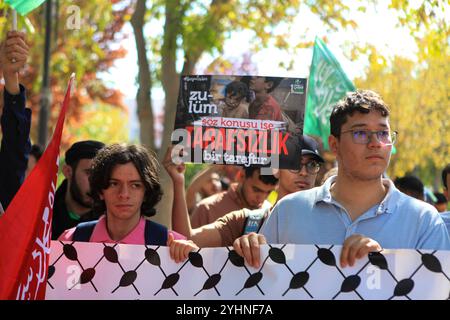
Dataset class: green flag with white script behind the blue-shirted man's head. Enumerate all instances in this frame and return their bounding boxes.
[303,37,356,150]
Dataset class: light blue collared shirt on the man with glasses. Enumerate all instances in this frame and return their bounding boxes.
[260,176,450,250]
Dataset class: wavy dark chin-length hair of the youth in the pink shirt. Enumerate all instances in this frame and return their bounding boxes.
[89,144,163,217]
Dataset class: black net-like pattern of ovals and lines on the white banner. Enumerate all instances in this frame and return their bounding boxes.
[48,242,450,300]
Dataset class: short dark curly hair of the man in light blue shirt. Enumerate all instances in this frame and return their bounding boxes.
[330,90,389,138]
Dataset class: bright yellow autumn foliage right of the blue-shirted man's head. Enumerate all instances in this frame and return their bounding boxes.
[355,30,450,188]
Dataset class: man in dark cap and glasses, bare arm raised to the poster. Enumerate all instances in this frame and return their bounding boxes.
[165,136,324,247]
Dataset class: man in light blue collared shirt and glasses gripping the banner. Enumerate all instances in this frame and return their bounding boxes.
[234,90,450,267]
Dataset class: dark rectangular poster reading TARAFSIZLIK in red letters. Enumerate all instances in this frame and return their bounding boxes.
[172,75,306,168]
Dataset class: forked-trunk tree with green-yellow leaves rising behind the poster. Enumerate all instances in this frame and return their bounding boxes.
[132,0,366,224]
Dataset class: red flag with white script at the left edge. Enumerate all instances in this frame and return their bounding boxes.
[0,75,74,300]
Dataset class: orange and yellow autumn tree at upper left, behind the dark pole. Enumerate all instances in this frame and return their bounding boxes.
[0,0,132,150]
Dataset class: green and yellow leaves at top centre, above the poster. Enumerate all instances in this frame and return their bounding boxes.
[149,0,359,80]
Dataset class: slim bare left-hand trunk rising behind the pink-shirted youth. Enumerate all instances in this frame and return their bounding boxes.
[131,0,155,150]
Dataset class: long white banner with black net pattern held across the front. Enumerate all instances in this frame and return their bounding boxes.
[46,241,450,300]
